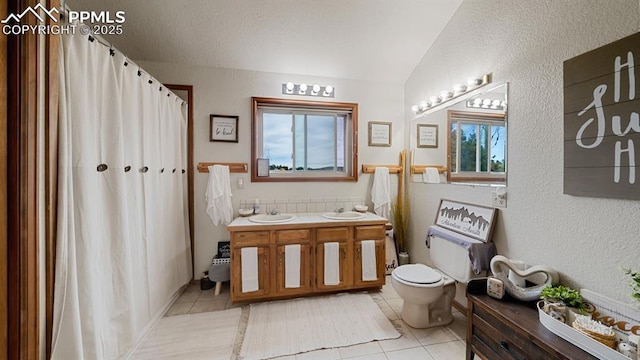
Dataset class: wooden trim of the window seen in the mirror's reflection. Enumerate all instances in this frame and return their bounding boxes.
[447,110,507,183]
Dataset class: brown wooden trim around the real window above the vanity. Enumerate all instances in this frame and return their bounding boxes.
[251,97,358,182]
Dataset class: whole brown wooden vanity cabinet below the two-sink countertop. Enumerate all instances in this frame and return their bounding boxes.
[228,221,386,302]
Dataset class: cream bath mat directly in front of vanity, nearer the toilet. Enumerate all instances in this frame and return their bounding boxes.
[238,293,400,360]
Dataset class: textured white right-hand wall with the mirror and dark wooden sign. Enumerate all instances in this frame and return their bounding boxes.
[405,0,640,302]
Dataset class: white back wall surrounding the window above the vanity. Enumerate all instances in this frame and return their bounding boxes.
[138,62,405,279]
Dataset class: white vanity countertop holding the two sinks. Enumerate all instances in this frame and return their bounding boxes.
[227,212,389,231]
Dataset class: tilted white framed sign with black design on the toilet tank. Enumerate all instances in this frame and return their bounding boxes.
[435,199,497,242]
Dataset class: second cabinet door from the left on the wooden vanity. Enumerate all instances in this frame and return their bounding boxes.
[276,242,312,296]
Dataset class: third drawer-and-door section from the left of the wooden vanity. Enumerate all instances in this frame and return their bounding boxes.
[315,226,353,291]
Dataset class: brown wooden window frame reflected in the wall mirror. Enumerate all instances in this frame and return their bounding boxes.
[447,110,508,184]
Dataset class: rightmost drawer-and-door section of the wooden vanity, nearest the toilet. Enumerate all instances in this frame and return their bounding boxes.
[353,225,386,287]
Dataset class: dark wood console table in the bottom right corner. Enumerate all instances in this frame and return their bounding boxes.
[466,279,598,360]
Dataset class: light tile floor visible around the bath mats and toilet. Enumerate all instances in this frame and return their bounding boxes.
[165,277,466,360]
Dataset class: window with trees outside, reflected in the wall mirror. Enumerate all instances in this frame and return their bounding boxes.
[448,111,507,183]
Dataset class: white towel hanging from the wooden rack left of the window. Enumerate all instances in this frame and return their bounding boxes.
[205,165,233,225]
